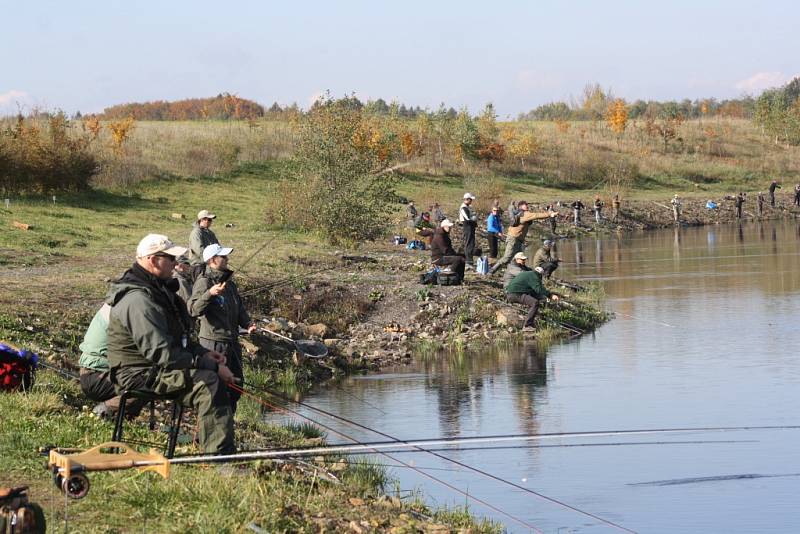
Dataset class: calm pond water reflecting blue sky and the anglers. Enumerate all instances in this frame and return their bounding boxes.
[264,222,800,533]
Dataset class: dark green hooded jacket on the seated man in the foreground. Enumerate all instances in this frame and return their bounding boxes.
[106,264,209,384]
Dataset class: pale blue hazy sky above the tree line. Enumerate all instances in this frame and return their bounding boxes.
[0,0,800,118]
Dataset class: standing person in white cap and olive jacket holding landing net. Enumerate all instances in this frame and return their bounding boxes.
[189,243,256,414]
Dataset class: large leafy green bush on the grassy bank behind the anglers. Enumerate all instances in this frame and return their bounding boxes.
[268,97,404,243]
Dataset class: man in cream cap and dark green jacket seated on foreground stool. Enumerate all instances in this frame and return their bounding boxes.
[106,234,235,454]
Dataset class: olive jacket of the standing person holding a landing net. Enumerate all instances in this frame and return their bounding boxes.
[189,267,250,343]
